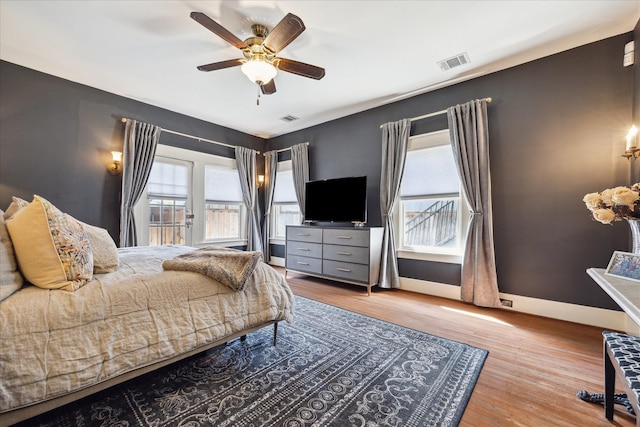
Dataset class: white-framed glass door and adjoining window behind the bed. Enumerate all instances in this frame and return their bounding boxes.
[134,144,247,246]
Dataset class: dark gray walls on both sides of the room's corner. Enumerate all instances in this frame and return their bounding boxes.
[0,27,640,309]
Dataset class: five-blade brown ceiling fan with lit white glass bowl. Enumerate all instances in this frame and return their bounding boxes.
[191,12,324,95]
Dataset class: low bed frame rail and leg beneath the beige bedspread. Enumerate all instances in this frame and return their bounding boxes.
[0,320,278,426]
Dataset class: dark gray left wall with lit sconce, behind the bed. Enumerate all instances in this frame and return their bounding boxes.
[0,61,264,241]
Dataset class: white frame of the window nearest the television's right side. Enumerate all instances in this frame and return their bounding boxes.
[393,129,470,264]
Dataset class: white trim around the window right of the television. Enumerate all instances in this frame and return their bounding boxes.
[393,129,471,264]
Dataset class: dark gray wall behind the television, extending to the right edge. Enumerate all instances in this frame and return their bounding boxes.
[267,33,637,309]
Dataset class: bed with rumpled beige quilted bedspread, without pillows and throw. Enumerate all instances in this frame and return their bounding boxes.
[0,200,294,425]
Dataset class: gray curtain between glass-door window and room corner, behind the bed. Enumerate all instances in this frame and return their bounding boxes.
[236,147,262,252]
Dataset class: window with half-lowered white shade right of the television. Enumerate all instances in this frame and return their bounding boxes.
[396,130,466,255]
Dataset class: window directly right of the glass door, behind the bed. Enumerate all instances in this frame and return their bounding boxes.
[204,165,242,240]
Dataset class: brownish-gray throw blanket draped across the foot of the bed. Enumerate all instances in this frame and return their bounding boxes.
[162,246,262,291]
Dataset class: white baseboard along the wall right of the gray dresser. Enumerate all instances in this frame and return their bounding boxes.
[400,277,640,335]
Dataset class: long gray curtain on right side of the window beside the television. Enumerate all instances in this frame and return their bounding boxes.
[447,99,501,307]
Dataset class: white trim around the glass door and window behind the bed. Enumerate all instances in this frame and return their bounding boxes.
[134,144,248,247]
